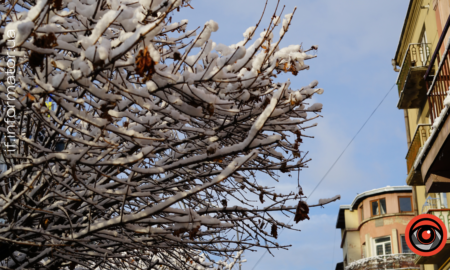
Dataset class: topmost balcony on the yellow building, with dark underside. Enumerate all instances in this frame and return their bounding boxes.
[397,43,430,109]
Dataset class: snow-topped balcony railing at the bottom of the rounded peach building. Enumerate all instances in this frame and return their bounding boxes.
[345,253,420,270]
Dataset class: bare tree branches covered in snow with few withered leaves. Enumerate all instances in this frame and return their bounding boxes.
[0,0,329,269]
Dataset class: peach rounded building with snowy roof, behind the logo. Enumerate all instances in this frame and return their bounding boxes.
[336,186,419,270]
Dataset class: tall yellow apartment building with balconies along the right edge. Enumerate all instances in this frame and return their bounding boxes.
[392,0,450,270]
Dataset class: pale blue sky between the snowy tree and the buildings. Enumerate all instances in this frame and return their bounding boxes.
[174,0,409,270]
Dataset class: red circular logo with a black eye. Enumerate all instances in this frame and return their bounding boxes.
[405,214,447,257]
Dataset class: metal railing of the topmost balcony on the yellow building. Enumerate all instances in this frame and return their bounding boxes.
[397,43,431,91]
